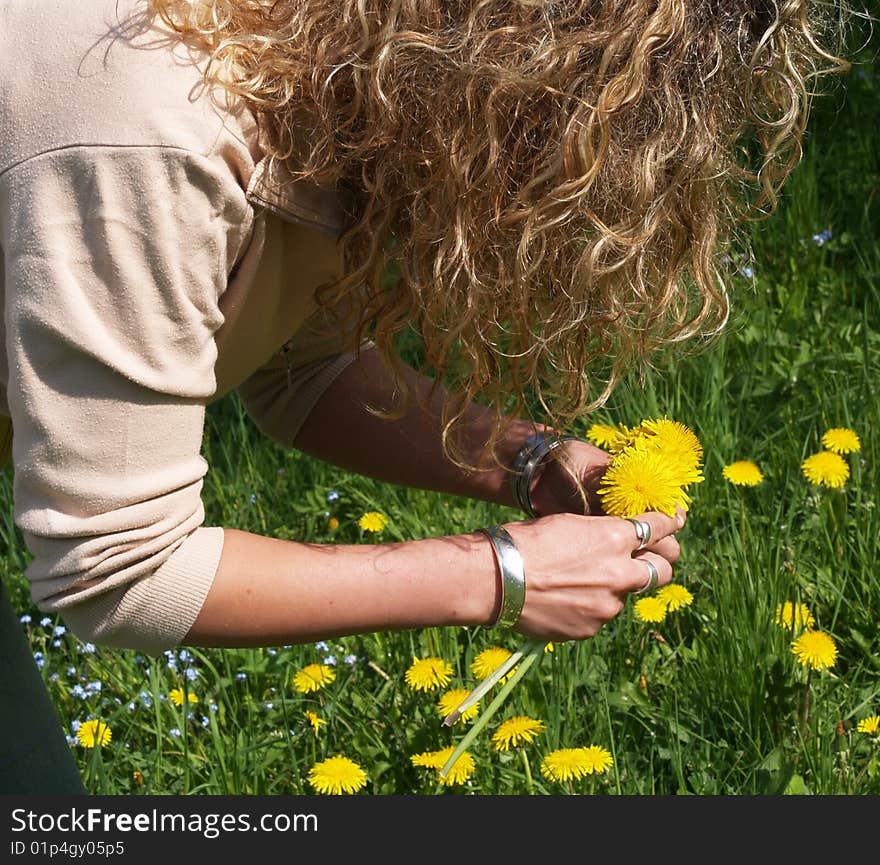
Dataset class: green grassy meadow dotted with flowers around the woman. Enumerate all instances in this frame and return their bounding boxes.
[0,44,880,796]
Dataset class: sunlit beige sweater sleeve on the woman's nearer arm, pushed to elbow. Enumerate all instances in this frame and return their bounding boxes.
[2,146,252,652]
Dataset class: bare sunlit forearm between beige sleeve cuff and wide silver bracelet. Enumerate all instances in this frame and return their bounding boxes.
[183,529,499,647]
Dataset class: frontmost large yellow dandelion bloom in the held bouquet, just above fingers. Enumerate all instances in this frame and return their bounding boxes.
[599,446,691,517]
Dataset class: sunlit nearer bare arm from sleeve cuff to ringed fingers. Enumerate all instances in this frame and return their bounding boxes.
[182,513,685,647]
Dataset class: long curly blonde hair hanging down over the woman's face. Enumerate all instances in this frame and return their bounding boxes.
[150,0,849,468]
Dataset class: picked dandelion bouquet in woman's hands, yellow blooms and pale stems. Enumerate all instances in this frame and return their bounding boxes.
[440,417,704,776]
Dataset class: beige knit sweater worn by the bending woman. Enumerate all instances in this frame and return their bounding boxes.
[0,0,364,652]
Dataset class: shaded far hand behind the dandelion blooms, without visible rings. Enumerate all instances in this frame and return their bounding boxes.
[531,440,611,517]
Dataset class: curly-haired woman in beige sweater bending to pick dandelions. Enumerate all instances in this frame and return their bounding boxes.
[0,0,845,788]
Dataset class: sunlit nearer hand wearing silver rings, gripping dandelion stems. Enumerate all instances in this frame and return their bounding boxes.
[505,510,686,641]
